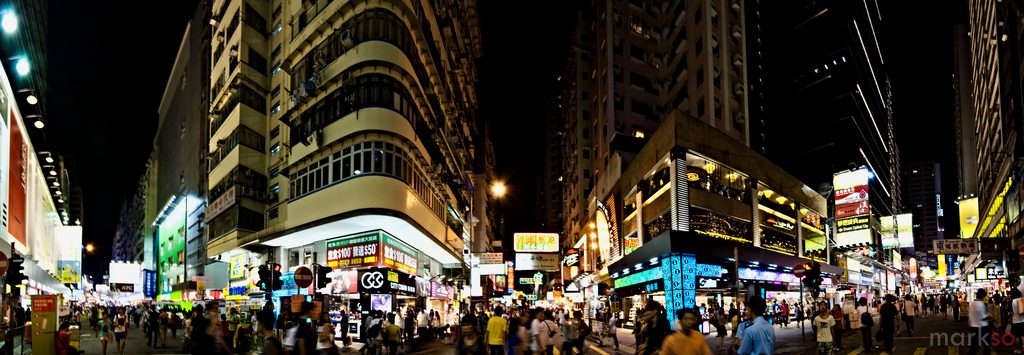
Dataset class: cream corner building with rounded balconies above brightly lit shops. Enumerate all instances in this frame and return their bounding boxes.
[207,0,489,308]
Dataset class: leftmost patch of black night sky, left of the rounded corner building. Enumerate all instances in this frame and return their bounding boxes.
[46,0,196,277]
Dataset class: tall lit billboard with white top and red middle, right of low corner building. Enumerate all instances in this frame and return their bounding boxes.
[833,169,871,248]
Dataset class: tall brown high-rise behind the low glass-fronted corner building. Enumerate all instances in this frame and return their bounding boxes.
[565,0,750,243]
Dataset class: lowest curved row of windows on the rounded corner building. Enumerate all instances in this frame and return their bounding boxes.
[289,141,444,218]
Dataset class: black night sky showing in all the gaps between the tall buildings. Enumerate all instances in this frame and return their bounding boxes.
[39,0,950,282]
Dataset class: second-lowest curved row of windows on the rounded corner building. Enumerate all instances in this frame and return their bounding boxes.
[290,74,426,145]
